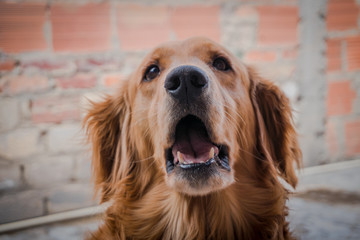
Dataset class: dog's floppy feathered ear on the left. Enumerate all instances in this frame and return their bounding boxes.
[83,81,130,202]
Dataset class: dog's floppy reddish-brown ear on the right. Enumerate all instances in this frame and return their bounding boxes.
[248,68,302,188]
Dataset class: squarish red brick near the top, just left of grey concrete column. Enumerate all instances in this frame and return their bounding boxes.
[258,6,299,45]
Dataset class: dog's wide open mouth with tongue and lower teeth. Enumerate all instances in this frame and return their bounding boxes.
[165,115,230,173]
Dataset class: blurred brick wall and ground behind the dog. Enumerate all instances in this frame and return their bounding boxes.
[0,0,360,239]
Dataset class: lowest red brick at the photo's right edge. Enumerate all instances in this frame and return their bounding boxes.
[345,119,360,156]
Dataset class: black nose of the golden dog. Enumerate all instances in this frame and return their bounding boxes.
[164,65,209,103]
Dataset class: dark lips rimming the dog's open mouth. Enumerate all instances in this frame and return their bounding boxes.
[165,114,230,173]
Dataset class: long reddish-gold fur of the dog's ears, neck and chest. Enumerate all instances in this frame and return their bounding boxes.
[84,38,301,240]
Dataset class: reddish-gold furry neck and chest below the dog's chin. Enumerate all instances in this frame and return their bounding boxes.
[108,182,285,239]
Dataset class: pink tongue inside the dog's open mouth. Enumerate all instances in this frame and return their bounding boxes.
[172,127,219,163]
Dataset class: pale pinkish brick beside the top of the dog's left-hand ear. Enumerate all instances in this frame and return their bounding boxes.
[31,96,80,123]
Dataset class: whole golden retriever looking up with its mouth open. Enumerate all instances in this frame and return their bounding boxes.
[84,38,301,240]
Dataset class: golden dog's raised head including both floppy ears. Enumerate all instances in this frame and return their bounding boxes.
[85,38,301,198]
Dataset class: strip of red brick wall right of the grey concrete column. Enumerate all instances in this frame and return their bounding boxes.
[325,0,360,161]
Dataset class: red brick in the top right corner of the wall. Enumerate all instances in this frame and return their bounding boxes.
[326,0,360,31]
